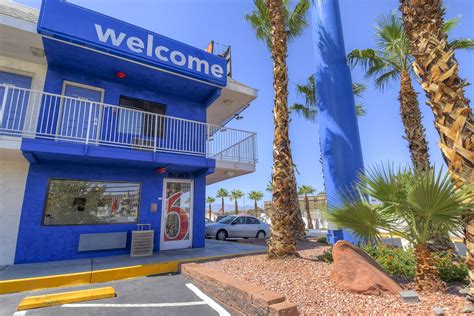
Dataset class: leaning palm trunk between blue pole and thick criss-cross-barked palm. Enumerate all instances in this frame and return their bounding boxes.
[398,70,430,171]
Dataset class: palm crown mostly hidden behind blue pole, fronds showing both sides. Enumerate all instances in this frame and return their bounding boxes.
[289,75,367,122]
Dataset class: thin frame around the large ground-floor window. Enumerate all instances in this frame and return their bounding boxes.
[41,178,143,227]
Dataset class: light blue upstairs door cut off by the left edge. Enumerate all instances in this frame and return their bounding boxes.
[0,71,31,132]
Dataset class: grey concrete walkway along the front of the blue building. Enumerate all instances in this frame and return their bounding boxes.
[0,240,267,281]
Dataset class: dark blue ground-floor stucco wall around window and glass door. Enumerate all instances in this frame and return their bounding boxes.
[15,161,205,264]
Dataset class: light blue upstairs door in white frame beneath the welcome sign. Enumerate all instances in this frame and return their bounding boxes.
[57,83,103,140]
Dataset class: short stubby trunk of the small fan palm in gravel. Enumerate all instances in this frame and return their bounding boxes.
[415,245,444,292]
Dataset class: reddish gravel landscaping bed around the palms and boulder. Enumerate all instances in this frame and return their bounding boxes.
[205,241,464,315]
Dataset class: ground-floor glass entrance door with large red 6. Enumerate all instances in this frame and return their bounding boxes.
[160,179,194,250]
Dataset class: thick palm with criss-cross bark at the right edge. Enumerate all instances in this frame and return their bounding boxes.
[400,0,474,311]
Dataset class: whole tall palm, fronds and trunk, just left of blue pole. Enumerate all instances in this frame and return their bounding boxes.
[245,0,310,258]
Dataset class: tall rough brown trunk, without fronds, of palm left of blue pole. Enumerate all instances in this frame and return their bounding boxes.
[266,0,299,258]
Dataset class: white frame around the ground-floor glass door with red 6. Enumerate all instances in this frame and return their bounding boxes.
[160,178,194,250]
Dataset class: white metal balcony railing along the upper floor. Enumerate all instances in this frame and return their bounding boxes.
[0,85,257,163]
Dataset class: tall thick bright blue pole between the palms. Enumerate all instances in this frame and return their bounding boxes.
[311,0,364,244]
